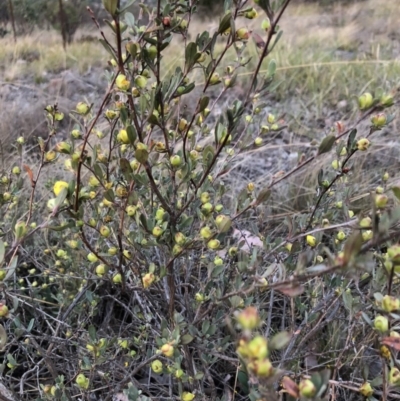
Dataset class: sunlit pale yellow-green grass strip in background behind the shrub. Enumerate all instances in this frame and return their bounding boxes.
[0,0,400,97]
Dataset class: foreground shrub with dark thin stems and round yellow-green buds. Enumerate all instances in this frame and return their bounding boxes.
[0,0,400,401]
